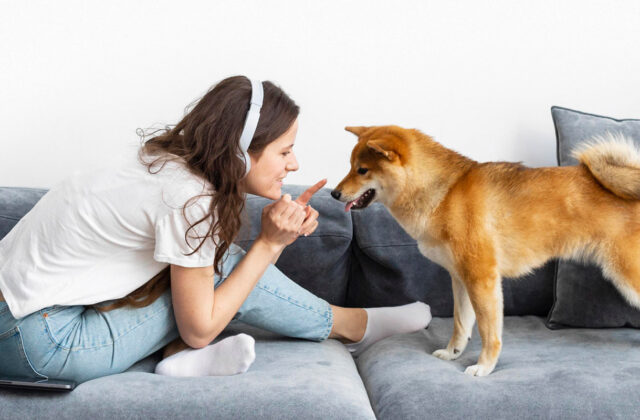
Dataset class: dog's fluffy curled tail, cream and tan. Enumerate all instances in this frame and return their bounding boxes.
[572,132,640,200]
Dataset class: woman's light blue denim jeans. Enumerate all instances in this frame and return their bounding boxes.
[0,245,333,383]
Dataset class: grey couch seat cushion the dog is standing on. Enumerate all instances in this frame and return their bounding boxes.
[356,316,640,420]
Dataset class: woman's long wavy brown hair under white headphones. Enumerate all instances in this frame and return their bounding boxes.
[94,76,300,311]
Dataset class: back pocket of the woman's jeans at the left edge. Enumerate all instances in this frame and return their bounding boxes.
[0,326,47,379]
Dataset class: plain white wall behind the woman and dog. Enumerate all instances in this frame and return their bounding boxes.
[0,0,640,187]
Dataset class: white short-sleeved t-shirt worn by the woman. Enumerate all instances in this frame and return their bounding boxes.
[0,151,215,318]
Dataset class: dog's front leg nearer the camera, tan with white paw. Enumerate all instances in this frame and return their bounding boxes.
[464,274,504,376]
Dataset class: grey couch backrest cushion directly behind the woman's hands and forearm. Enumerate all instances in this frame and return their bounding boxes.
[236,185,353,305]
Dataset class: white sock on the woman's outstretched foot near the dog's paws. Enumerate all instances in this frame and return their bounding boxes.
[345,302,431,357]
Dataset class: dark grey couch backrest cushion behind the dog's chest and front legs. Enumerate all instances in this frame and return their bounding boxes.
[347,203,554,316]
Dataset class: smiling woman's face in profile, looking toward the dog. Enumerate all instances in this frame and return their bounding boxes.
[241,118,298,200]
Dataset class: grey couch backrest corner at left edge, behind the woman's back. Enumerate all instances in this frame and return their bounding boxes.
[0,187,47,239]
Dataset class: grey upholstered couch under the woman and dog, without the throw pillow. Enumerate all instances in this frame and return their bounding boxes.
[0,186,640,419]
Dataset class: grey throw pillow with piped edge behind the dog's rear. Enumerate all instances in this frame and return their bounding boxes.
[547,106,640,329]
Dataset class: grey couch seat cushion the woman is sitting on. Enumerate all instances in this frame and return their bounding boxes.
[0,321,375,419]
